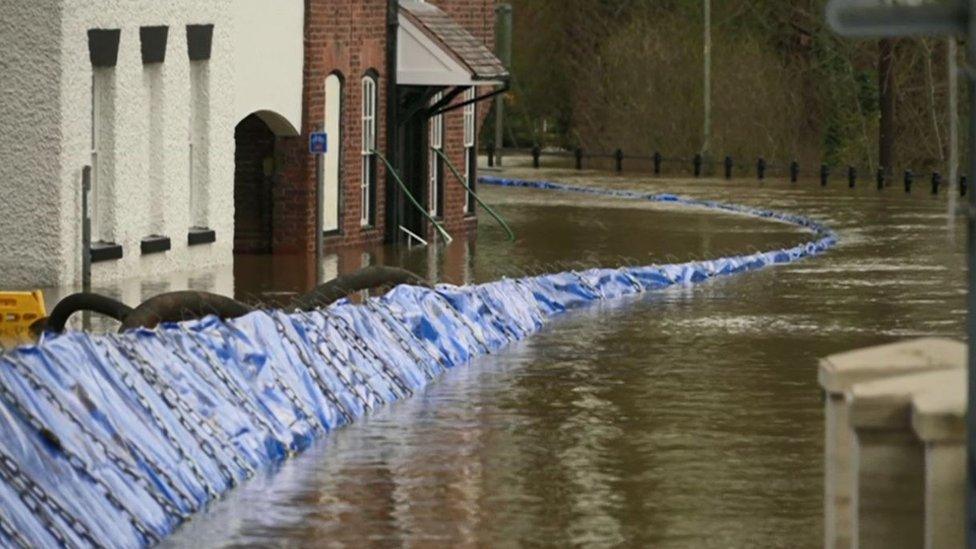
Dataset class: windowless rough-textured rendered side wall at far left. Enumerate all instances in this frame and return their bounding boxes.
[0,0,62,290]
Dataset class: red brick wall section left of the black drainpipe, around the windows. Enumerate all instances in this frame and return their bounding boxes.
[274,0,387,253]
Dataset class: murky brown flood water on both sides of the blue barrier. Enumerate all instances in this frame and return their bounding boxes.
[158,165,965,547]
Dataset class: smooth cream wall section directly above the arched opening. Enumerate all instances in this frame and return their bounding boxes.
[234,0,305,135]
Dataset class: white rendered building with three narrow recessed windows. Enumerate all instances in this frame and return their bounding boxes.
[0,0,304,289]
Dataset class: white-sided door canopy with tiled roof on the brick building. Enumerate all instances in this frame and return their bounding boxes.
[397,0,509,87]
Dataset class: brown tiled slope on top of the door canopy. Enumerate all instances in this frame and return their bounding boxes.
[400,0,508,80]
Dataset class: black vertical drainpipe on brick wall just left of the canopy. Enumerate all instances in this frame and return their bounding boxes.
[384,0,403,243]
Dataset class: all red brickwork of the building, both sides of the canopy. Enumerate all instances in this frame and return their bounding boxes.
[273,0,494,254]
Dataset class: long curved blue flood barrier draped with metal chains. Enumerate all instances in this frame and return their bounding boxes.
[0,179,836,547]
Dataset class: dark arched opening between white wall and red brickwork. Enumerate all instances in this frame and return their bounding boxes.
[234,114,275,254]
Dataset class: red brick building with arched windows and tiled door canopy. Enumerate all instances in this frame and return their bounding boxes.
[235,0,508,256]
